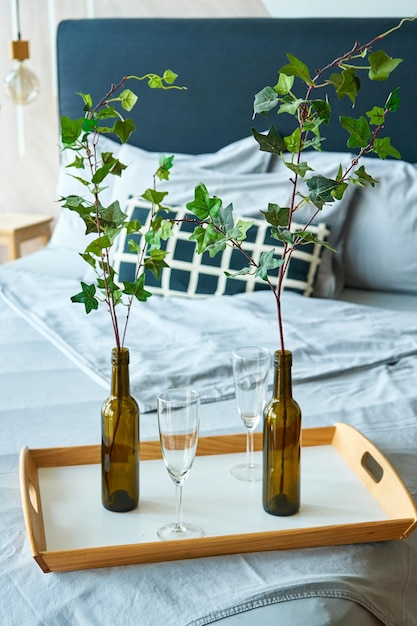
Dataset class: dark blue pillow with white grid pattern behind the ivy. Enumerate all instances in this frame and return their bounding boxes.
[114,198,328,297]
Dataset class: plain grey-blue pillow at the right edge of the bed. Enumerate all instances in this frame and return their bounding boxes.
[344,157,417,293]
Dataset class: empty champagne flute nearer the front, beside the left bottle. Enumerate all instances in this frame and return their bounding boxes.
[157,387,203,540]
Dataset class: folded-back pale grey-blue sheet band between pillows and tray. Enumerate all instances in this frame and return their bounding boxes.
[0,249,417,412]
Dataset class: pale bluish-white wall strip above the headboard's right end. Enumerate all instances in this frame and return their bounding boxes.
[262,0,417,17]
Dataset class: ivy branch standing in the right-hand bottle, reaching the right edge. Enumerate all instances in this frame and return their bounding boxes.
[187,17,416,352]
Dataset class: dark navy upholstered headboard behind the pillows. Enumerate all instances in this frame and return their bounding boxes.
[57,18,417,162]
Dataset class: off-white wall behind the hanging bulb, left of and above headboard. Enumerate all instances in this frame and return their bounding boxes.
[0,0,268,263]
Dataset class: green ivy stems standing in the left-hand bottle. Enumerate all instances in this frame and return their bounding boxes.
[60,70,185,350]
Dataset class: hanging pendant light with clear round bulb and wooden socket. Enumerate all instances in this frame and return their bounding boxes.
[3,0,39,104]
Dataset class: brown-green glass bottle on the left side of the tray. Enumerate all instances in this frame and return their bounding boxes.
[101,348,139,513]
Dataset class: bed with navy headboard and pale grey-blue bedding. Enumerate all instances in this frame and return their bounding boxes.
[0,18,417,626]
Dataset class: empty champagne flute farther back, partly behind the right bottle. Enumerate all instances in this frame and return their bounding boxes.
[230,346,271,482]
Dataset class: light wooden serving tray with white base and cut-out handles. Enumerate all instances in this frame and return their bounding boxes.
[20,423,417,572]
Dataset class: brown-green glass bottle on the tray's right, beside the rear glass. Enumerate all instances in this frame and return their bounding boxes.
[263,350,301,516]
